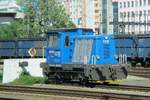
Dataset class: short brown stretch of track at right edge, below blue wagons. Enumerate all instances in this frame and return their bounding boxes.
[129,67,150,78]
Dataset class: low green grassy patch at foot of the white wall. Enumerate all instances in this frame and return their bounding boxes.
[10,74,46,85]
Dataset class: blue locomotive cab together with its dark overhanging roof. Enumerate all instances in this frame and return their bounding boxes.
[46,29,93,64]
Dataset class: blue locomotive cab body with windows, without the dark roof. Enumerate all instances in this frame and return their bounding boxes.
[46,32,71,64]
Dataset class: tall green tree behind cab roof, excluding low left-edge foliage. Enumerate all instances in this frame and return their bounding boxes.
[18,0,75,37]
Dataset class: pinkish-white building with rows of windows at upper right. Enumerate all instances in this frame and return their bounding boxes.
[113,0,150,34]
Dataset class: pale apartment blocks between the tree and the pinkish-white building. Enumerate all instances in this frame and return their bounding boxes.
[63,0,112,33]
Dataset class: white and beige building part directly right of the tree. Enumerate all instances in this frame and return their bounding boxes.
[63,0,95,29]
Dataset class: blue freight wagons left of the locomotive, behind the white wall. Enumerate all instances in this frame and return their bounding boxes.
[0,39,47,59]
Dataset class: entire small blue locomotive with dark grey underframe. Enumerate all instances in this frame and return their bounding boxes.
[41,28,127,84]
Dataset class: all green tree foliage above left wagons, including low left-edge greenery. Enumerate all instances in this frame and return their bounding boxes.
[0,0,75,39]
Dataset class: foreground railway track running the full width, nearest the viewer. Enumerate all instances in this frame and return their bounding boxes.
[0,85,150,100]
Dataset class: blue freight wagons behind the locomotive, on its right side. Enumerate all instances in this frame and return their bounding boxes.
[115,34,150,67]
